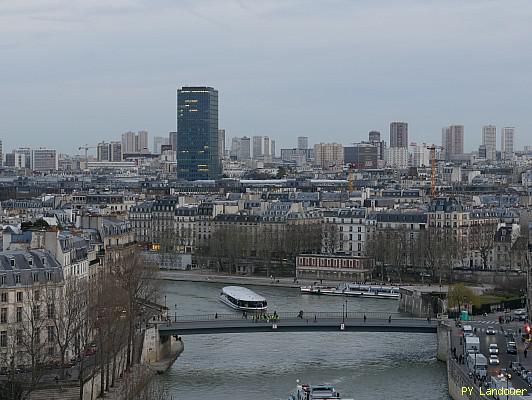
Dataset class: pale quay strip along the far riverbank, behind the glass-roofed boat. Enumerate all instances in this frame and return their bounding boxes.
[158,269,410,289]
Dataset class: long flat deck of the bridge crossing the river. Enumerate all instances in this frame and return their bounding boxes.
[159,315,438,336]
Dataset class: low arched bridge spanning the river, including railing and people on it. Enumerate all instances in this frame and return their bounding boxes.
[158,312,438,337]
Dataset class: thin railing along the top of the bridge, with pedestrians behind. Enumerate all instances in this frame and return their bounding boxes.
[168,311,426,322]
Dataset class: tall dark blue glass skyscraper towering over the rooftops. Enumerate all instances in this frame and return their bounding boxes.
[176,86,222,180]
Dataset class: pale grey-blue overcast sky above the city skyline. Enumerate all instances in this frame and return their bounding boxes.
[0,0,532,153]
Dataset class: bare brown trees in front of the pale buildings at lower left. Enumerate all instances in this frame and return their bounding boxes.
[0,246,158,399]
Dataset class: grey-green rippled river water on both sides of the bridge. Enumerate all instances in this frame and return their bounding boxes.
[157,282,450,400]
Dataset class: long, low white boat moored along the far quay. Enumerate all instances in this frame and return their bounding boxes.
[300,282,399,300]
